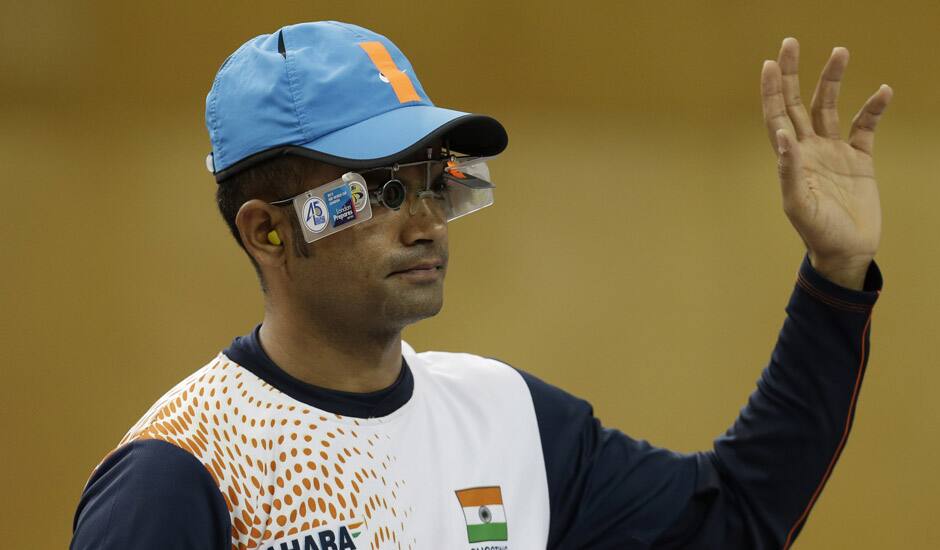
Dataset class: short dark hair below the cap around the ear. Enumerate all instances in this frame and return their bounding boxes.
[215,155,318,291]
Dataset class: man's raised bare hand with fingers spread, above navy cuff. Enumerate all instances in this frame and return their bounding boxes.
[761,38,893,289]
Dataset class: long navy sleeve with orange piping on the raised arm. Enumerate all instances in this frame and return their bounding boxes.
[522,259,881,550]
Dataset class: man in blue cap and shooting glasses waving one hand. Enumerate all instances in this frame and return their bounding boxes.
[72,22,891,550]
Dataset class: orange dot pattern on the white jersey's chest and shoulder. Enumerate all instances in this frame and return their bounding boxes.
[105,354,415,550]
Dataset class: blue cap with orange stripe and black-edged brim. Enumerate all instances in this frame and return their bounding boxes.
[206,21,508,182]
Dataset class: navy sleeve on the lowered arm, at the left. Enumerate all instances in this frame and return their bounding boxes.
[69,439,231,550]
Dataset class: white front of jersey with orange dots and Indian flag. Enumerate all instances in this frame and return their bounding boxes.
[114,344,549,550]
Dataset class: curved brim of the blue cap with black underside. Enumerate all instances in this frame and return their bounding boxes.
[215,105,509,181]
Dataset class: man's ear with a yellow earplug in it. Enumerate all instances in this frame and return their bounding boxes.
[235,199,293,267]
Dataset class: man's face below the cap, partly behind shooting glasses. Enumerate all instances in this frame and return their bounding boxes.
[286,151,447,332]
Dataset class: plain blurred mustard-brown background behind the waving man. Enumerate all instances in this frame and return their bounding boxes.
[0,0,940,549]
